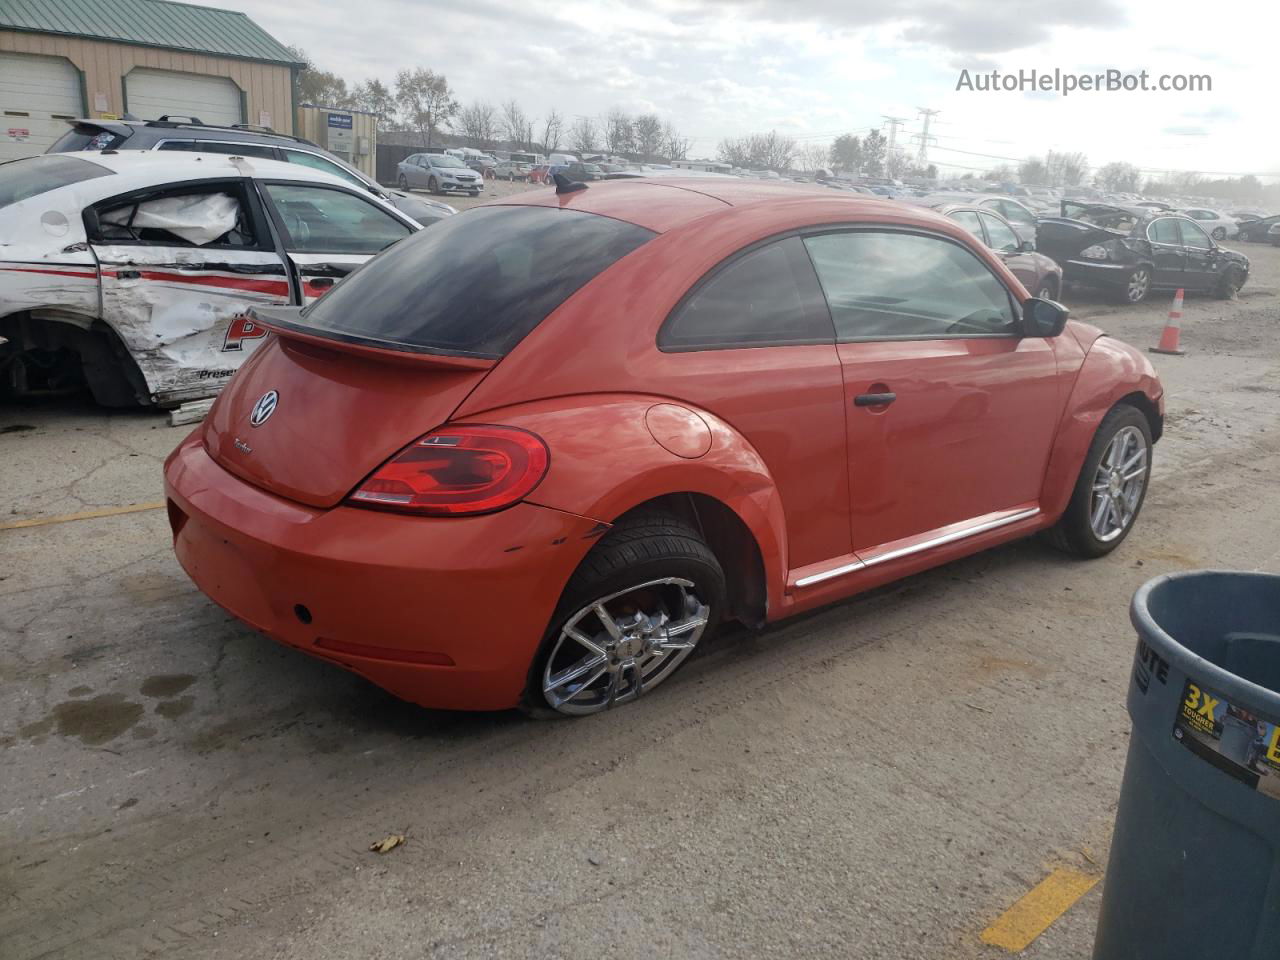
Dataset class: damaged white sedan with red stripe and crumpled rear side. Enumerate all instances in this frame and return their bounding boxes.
[0,151,421,407]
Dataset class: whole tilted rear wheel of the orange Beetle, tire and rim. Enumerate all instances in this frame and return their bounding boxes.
[524,512,727,717]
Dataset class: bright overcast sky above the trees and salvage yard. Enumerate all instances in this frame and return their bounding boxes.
[204,0,1280,174]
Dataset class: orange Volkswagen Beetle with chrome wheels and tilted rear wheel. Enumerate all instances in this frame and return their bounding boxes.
[165,178,1164,714]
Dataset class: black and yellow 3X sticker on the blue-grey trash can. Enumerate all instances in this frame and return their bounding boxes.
[1174,680,1280,800]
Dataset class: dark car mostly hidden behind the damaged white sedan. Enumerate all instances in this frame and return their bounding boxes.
[45,116,457,227]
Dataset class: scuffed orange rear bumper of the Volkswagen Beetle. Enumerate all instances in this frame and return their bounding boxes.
[165,434,603,710]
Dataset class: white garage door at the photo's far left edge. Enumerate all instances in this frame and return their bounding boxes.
[0,52,84,161]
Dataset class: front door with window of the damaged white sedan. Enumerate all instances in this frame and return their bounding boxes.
[260,180,416,305]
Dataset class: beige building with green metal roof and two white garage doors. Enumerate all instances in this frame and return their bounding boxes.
[0,0,300,161]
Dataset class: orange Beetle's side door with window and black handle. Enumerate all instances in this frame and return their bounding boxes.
[805,228,1064,562]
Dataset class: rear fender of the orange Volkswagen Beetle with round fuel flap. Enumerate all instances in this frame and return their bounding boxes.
[468,394,787,609]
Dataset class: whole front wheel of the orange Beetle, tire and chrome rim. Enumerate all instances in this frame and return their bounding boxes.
[1048,403,1152,559]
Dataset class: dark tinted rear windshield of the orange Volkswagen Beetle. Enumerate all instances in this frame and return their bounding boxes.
[302,206,655,357]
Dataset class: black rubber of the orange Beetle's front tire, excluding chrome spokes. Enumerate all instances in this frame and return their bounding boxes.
[1046,403,1152,559]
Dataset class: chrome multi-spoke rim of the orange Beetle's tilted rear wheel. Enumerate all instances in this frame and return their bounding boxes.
[543,577,710,716]
